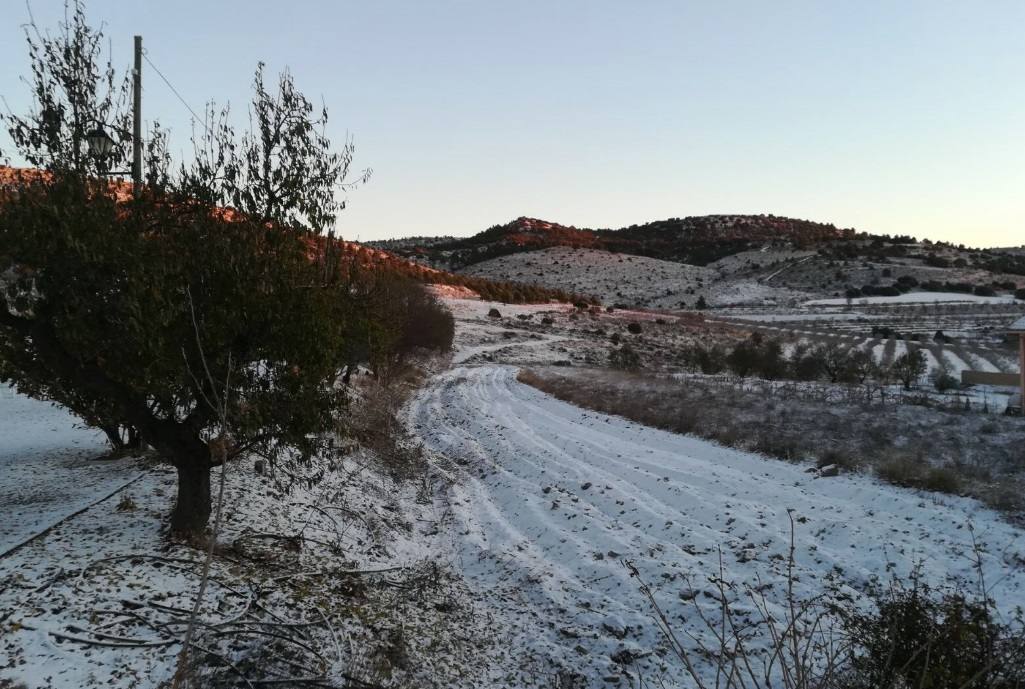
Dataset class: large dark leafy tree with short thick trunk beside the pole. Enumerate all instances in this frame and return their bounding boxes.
[0,4,377,531]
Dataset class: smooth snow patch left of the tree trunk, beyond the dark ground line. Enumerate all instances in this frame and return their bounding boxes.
[0,386,139,553]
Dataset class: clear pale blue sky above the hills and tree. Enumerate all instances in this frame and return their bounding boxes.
[0,0,1025,246]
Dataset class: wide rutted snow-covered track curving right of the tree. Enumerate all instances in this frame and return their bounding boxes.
[409,366,1025,686]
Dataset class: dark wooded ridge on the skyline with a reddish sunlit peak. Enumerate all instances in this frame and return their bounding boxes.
[380,215,856,270]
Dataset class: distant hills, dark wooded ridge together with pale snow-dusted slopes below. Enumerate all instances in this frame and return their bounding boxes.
[373,215,1025,308]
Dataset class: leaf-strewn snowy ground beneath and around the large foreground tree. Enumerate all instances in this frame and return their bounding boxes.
[0,377,530,689]
